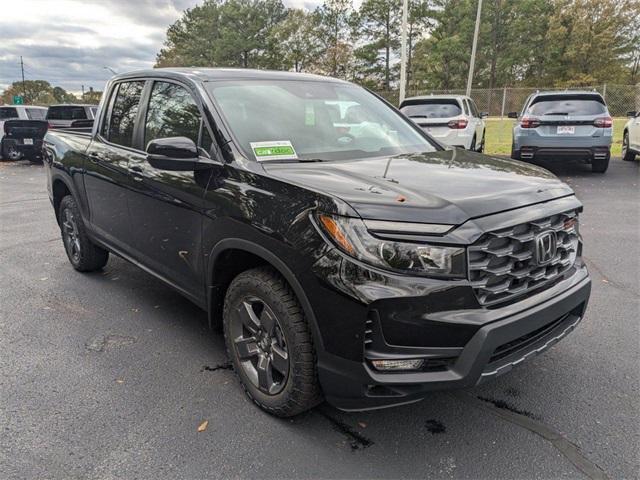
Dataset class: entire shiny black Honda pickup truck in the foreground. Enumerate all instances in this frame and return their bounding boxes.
[45,68,591,416]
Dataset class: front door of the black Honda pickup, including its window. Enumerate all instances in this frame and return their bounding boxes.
[129,80,212,302]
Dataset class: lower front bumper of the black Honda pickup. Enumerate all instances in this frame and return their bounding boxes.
[319,265,591,410]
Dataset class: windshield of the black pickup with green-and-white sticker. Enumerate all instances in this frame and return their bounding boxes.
[206,80,436,161]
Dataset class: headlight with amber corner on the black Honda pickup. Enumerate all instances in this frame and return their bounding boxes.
[317,214,466,278]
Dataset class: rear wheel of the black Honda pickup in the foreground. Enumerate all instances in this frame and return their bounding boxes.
[58,195,109,272]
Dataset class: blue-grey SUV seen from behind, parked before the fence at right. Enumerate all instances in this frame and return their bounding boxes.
[509,91,613,173]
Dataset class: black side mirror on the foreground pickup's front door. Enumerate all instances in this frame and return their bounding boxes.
[147,137,202,172]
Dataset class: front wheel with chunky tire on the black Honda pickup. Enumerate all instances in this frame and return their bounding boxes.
[223,267,322,417]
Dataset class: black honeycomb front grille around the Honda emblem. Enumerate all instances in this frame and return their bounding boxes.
[469,211,579,306]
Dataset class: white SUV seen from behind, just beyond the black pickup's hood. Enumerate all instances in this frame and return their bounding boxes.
[400,95,488,152]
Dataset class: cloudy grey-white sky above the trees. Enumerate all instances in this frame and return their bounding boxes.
[0,0,319,93]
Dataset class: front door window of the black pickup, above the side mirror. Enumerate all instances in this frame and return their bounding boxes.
[144,82,202,146]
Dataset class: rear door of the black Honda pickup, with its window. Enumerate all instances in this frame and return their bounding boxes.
[85,80,145,249]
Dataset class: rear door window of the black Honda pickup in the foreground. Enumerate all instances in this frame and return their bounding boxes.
[107,81,144,147]
